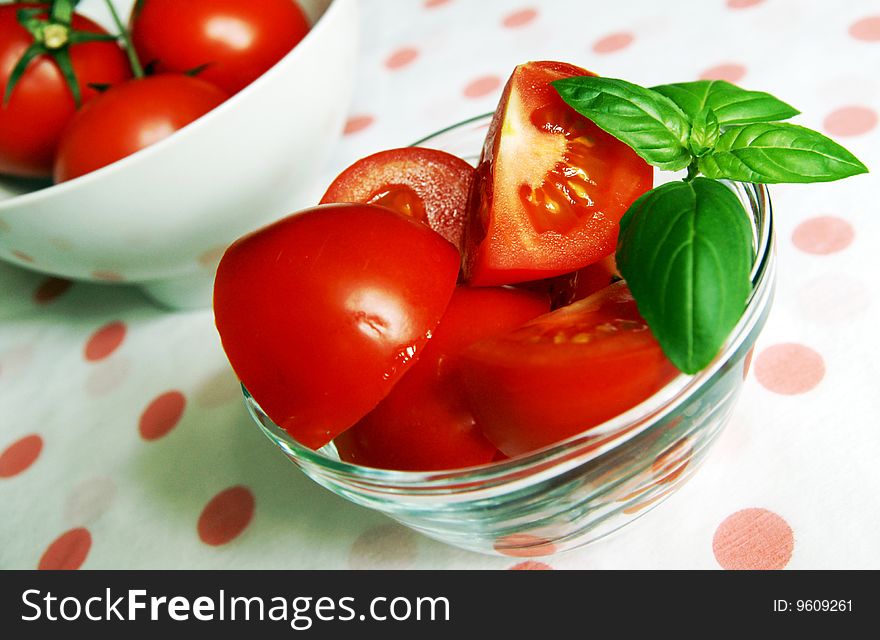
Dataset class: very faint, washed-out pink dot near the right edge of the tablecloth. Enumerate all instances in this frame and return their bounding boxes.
[798,273,871,325]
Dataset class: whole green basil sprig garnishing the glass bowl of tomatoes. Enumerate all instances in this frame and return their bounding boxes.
[553,76,868,374]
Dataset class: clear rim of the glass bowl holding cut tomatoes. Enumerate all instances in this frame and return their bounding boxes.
[242,113,775,492]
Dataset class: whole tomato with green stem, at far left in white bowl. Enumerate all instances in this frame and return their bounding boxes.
[0,3,131,177]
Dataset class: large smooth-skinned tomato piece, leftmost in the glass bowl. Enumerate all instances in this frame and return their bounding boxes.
[214,204,459,449]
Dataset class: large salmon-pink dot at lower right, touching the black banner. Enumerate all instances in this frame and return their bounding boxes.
[712,509,794,570]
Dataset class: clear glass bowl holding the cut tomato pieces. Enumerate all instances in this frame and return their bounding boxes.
[244,115,775,556]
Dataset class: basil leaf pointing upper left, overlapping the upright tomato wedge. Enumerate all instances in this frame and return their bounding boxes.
[553,76,693,171]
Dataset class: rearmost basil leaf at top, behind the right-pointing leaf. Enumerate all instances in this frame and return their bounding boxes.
[653,80,800,126]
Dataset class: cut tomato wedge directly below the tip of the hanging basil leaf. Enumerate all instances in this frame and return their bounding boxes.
[460,282,678,456]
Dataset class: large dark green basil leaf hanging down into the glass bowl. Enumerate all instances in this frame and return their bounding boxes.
[616,178,754,374]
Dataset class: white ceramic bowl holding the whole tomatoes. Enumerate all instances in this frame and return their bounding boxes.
[0,0,357,308]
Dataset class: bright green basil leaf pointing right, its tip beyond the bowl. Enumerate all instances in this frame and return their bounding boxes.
[699,122,868,184]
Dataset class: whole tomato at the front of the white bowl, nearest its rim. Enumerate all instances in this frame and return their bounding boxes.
[55,74,227,182]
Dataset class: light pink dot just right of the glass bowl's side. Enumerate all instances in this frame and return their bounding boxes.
[755,343,825,396]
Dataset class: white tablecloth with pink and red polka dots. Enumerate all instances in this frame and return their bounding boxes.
[0,0,880,569]
